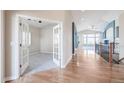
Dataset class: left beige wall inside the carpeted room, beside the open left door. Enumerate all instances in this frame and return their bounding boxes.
[29,26,40,55]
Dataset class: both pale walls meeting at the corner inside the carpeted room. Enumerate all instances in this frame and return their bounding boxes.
[29,25,53,55]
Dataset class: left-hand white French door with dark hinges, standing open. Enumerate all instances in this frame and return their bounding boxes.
[19,20,29,75]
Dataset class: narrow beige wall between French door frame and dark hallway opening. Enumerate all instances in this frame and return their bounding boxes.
[62,10,72,67]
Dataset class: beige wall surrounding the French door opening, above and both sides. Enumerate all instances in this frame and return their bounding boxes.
[5,10,72,80]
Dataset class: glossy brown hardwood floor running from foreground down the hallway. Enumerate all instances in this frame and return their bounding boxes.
[7,49,124,83]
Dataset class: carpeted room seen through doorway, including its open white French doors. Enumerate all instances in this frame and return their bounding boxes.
[19,17,61,75]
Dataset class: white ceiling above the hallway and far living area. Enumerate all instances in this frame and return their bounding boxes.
[72,10,124,31]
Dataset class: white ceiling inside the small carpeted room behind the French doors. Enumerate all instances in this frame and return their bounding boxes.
[23,17,57,28]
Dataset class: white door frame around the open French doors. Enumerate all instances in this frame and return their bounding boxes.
[13,14,63,78]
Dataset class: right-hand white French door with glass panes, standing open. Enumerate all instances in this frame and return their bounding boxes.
[53,25,61,67]
